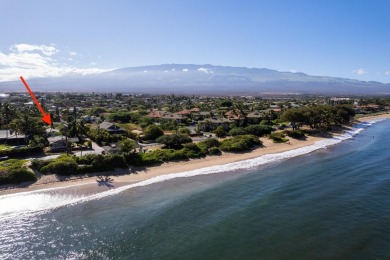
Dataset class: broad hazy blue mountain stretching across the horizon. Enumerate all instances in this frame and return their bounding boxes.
[0,64,390,95]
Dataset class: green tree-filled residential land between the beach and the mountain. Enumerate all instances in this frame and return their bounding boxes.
[0,93,390,183]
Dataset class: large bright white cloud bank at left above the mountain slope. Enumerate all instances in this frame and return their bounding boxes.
[0,44,108,81]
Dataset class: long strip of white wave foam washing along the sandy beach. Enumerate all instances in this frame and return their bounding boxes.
[0,120,379,219]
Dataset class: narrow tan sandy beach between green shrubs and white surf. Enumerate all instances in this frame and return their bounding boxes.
[0,113,390,196]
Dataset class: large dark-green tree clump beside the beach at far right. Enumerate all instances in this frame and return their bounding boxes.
[280,105,355,130]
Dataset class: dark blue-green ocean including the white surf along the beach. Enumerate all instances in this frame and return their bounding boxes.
[0,120,390,259]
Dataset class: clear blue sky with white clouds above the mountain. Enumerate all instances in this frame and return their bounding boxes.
[0,0,390,83]
